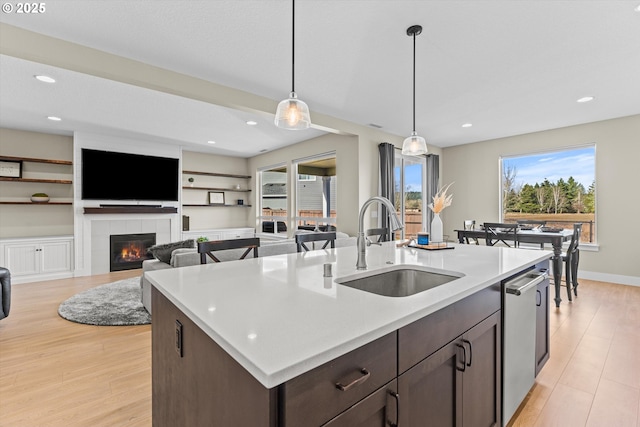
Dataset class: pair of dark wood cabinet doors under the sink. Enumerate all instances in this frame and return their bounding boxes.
[398,312,502,427]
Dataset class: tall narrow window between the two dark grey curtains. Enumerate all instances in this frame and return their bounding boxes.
[393,151,426,238]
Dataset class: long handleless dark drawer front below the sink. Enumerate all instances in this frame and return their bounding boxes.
[398,283,500,374]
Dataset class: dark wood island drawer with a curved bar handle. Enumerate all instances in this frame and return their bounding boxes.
[279,332,397,427]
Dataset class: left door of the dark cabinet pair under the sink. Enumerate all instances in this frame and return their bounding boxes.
[398,339,464,427]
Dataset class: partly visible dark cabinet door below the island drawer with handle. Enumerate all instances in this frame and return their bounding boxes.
[324,380,400,427]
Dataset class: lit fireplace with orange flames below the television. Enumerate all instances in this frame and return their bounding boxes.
[109,233,156,271]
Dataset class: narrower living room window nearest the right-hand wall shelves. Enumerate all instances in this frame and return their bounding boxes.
[258,165,288,237]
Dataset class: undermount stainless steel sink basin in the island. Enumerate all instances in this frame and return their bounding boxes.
[336,266,463,297]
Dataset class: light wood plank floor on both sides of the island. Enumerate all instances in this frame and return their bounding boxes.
[0,270,640,427]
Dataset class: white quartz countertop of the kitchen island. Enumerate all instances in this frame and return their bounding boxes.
[146,242,552,388]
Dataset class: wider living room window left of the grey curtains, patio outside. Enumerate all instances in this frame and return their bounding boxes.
[294,153,338,231]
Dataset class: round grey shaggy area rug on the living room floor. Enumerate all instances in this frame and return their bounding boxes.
[58,277,151,326]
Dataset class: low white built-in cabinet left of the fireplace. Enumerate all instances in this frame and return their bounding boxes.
[0,236,73,283]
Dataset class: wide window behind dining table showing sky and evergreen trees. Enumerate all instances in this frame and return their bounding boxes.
[500,144,596,243]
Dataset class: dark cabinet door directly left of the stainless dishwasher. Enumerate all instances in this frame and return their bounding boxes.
[462,311,502,427]
